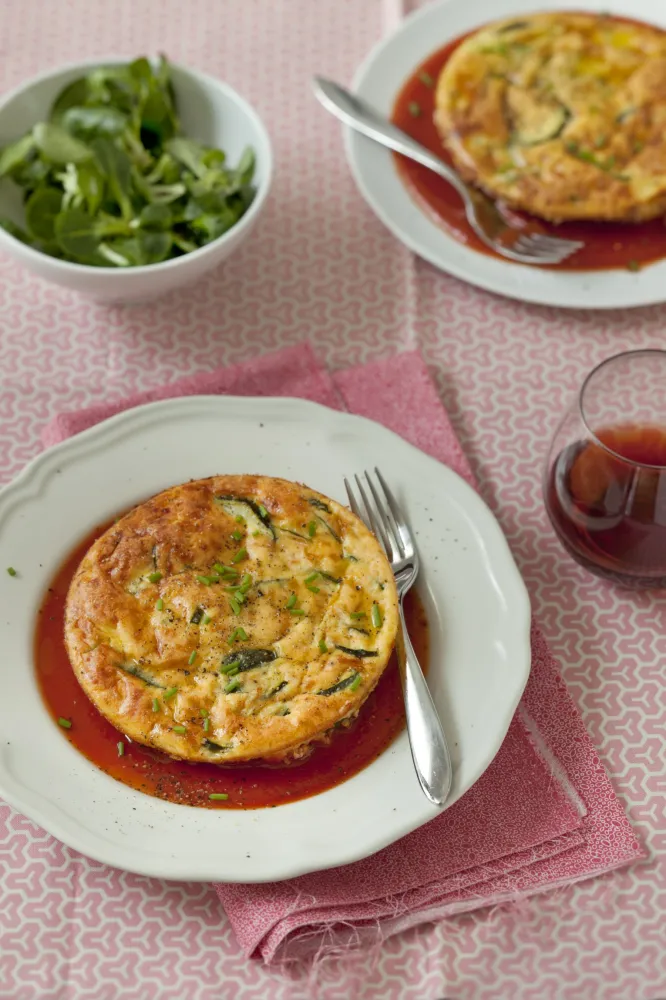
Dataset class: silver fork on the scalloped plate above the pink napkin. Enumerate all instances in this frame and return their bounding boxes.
[345,469,453,806]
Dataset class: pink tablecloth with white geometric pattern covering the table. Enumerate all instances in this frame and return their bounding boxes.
[0,0,666,1000]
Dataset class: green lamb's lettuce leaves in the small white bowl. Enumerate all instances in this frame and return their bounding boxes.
[0,56,255,267]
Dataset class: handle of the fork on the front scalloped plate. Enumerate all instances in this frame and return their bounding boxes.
[398,600,453,806]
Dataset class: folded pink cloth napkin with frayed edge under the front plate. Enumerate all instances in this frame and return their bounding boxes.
[43,344,643,962]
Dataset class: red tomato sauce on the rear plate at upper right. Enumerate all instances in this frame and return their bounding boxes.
[392,17,666,271]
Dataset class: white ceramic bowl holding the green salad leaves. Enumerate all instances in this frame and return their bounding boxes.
[0,56,273,302]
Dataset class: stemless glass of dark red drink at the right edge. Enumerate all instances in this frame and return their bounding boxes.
[543,350,666,588]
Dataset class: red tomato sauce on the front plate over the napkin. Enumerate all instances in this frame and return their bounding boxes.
[35,526,428,809]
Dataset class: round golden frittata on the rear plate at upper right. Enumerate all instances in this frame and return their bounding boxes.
[435,11,666,222]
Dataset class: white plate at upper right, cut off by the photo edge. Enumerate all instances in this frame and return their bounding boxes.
[345,0,666,309]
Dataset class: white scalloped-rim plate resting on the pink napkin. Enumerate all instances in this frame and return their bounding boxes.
[0,396,530,882]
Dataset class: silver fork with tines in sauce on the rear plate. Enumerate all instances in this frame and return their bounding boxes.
[314,76,584,265]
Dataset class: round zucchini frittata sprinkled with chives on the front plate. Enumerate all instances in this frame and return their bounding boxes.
[65,475,398,763]
